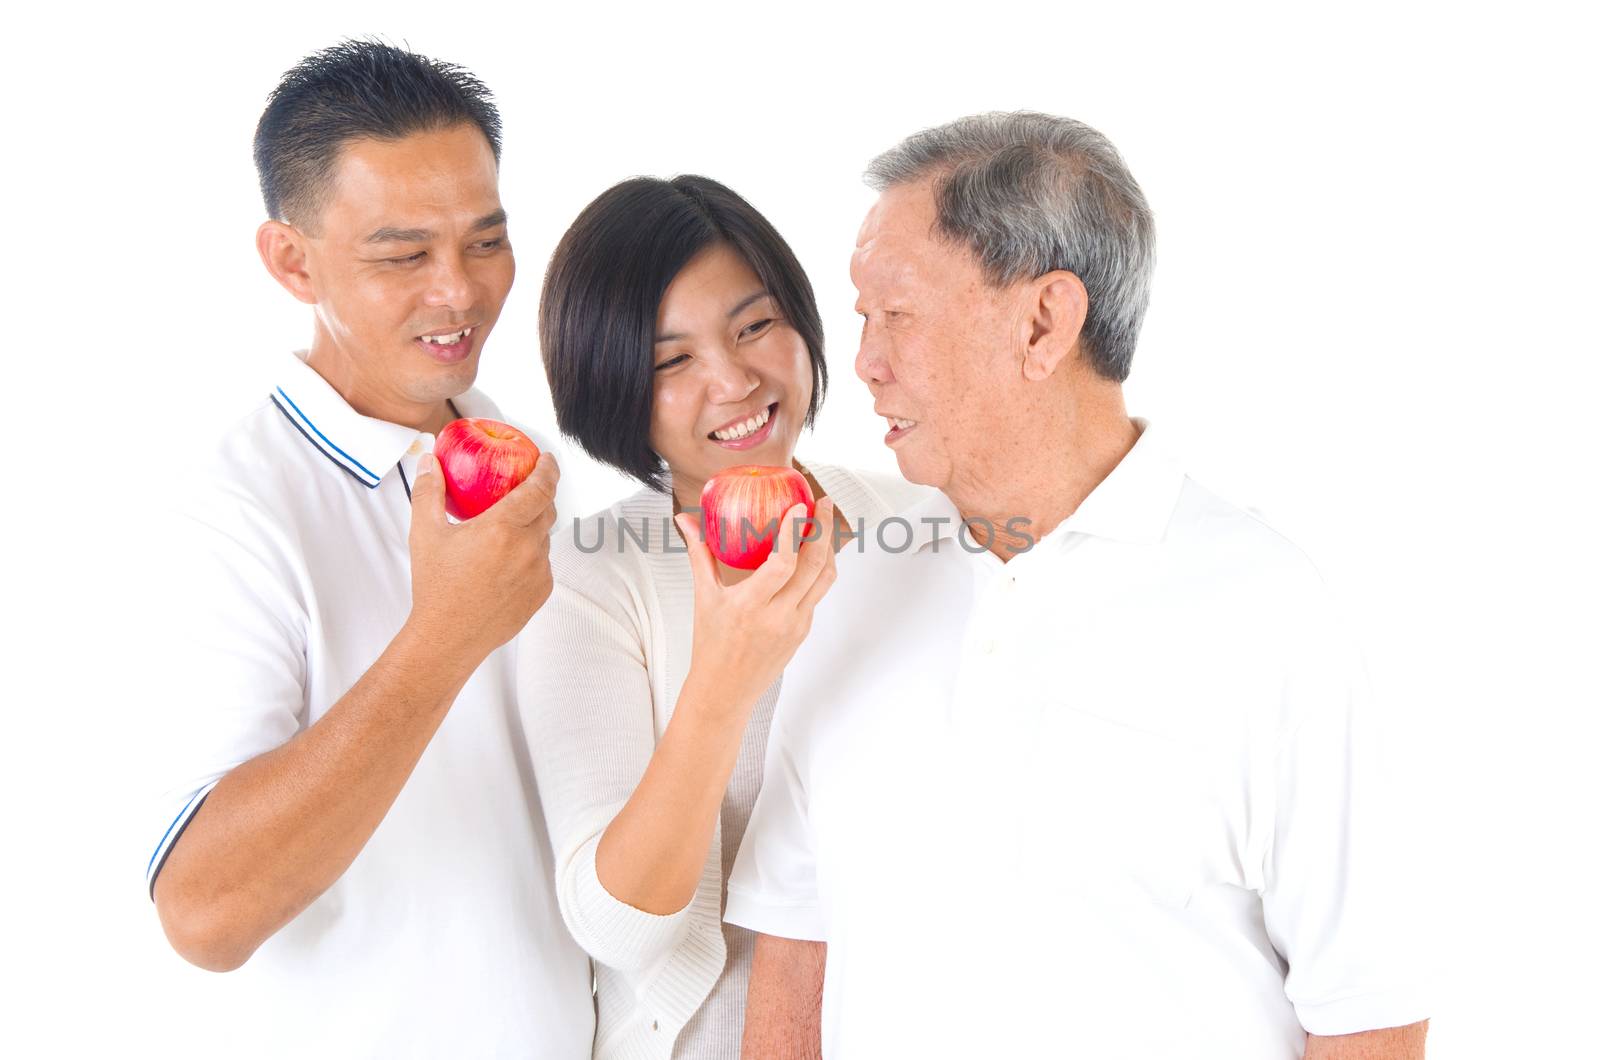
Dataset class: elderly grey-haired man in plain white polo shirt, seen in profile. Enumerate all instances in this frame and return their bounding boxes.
[726,114,1427,1060]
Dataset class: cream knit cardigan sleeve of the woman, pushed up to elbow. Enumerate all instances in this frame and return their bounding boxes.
[517,550,694,972]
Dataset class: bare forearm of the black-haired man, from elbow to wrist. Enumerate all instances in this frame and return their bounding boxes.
[155,624,480,970]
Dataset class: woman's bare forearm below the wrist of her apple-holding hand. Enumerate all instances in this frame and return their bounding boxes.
[595,673,749,916]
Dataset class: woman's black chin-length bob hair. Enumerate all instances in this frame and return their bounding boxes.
[539,176,827,492]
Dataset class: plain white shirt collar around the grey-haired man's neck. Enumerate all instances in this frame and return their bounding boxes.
[885,416,1184,552]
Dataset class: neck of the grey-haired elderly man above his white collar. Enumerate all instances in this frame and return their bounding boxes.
[944,402,1139,562]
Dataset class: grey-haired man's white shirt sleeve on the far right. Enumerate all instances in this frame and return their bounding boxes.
[1262,591,1430,1034]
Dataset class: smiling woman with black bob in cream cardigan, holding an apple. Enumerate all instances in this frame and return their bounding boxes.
[518,176,925,1058]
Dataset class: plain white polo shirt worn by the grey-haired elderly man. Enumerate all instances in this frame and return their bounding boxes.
[726,418,1429,1060]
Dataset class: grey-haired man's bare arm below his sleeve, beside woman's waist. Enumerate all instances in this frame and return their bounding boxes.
[741,935,827,1060]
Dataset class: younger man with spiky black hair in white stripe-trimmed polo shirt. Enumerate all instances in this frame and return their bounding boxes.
[147,42,594,1057]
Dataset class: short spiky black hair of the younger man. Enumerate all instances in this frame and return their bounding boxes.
[256,40,501,226]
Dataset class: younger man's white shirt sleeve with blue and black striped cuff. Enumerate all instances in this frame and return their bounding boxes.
[142,490,307,897]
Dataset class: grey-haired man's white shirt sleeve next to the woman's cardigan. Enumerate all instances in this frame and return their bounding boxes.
[723,692,827,942]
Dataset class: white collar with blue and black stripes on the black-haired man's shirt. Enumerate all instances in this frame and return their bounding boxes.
[269,352,502,490]
